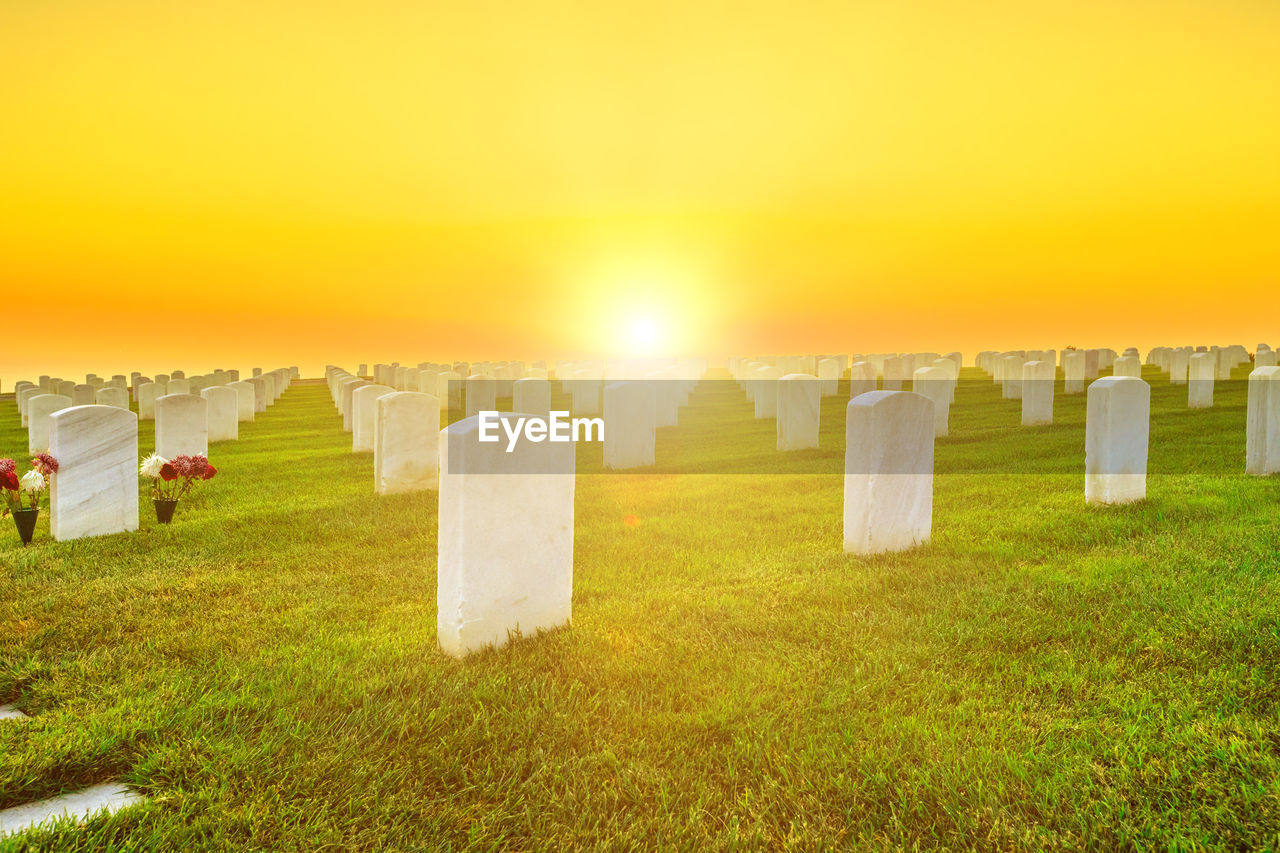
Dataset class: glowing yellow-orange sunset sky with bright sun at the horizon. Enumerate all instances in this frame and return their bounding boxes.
[0,0,1280,379]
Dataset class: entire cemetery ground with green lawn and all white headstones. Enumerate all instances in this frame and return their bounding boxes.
[0,347,1280,847]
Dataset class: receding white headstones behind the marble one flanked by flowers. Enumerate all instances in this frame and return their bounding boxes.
[14,368,297,459]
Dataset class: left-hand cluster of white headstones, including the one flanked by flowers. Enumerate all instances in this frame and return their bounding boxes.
[5,368,296,542]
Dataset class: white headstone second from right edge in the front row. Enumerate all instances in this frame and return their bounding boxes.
[1084,377,1151,505]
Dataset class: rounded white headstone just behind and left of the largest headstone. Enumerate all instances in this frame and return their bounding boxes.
[374,391,440,494]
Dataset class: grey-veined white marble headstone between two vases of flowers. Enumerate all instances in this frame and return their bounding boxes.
[49,401,138,542]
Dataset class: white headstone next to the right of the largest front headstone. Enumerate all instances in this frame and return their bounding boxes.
[845,391,933,555]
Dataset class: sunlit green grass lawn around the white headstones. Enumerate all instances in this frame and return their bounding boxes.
[0,368,1280,850]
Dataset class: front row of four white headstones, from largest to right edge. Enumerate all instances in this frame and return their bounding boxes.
[427,366,1280,656]
